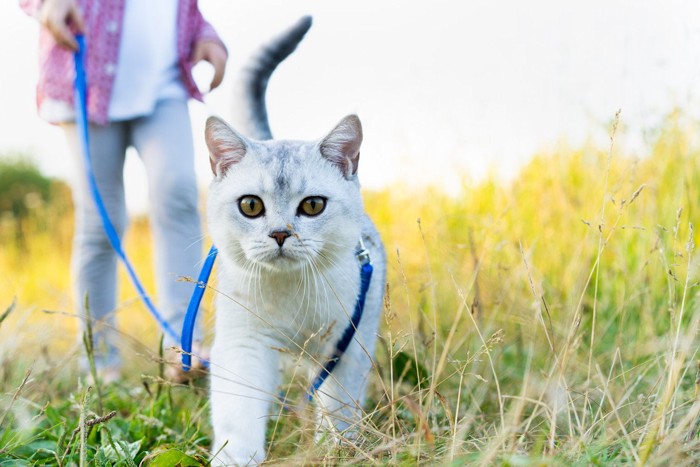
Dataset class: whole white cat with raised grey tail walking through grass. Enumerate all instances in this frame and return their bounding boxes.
[205,17,386,465]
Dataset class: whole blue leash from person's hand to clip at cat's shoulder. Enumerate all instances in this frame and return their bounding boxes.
[74,35,373,400]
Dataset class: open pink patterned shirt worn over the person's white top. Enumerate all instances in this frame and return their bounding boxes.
[19,0,224,125]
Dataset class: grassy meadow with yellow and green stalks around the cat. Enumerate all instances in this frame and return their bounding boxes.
[0,114,700,467]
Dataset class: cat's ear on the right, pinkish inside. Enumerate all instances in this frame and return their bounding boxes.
[319,115,362,179]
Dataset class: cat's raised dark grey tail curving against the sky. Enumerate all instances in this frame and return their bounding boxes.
[234,16,311,140]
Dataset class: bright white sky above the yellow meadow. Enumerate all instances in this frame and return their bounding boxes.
[0,0,700,211]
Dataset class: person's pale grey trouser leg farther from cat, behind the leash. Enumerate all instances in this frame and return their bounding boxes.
[63,123,128,369]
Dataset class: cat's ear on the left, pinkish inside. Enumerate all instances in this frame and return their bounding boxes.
[204,117,248,178]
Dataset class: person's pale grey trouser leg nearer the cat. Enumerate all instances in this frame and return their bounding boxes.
[132,99,202,345]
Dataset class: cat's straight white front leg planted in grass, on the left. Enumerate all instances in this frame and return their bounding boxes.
[210,334,279,465]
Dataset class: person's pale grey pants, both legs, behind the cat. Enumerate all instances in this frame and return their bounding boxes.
[64,99,202,366]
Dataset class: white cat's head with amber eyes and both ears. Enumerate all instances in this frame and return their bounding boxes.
[206,115,363,271]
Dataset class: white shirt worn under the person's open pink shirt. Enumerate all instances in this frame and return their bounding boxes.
[109,0,187,121]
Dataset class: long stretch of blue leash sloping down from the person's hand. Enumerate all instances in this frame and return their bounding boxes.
[75,35,179,341]
